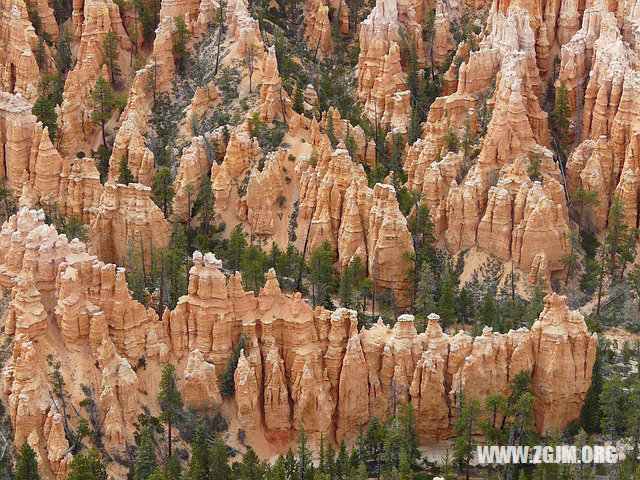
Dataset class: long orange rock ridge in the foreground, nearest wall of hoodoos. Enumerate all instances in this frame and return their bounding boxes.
[0,208,597,478]
